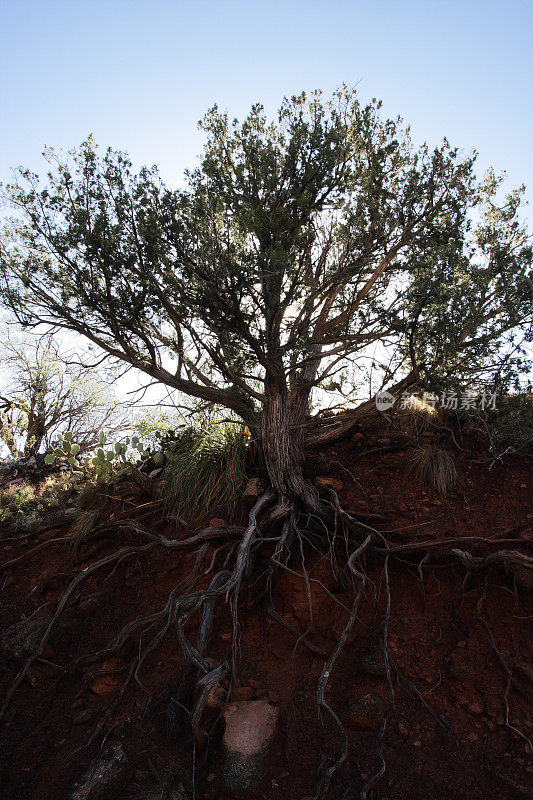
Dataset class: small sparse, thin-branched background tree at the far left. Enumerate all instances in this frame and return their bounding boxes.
[0,337,125,458]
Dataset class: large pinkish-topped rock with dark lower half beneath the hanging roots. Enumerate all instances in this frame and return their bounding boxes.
[222,700,279,798]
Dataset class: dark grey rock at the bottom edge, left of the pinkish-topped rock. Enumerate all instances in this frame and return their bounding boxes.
[69,741,133,800]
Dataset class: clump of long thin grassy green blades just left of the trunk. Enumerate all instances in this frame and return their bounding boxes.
[164,424,249,518]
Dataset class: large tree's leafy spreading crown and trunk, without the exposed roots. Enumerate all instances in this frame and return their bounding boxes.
[2,89,532,510]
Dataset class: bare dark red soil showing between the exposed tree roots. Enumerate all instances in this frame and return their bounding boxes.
[0,443,533,800]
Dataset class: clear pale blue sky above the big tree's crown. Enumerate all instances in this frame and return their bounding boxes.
[0,0,533,225]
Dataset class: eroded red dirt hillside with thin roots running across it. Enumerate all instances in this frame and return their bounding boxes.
[0,430,533,800]
